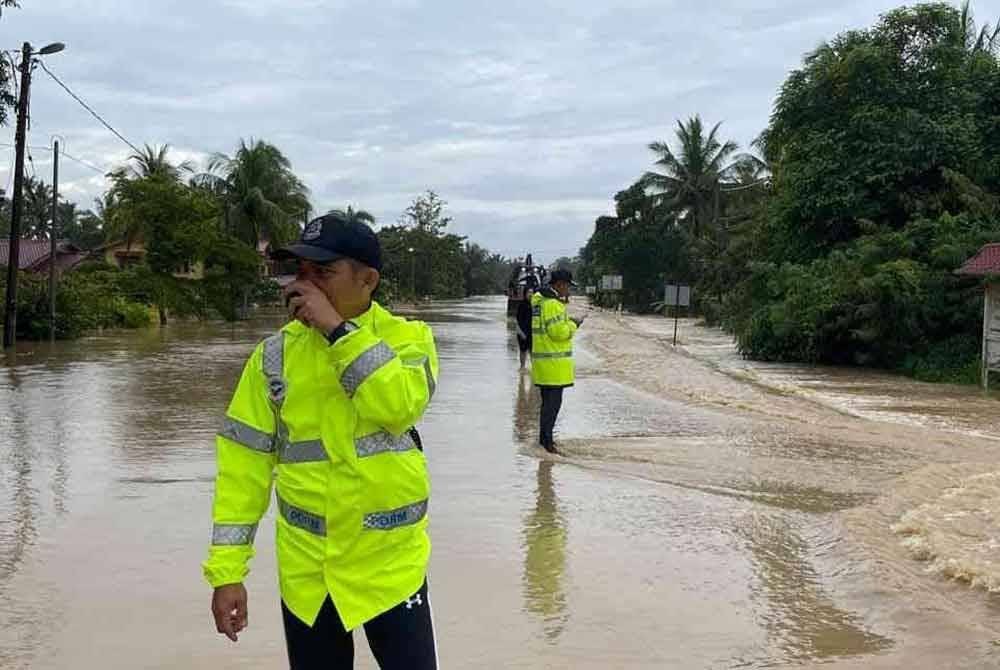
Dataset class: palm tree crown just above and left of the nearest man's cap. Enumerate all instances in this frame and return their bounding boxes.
[194,139,309,248]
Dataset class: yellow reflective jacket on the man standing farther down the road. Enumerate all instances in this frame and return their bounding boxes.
[531,289,576,386]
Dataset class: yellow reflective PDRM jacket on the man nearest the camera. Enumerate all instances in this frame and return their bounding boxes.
[203,303,438,630]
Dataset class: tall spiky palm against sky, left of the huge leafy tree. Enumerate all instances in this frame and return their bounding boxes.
[642,116,739,237]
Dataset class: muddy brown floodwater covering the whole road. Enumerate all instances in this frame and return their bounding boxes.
[0,299,1000,670]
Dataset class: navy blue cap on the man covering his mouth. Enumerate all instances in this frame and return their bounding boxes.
[271,212,382,271]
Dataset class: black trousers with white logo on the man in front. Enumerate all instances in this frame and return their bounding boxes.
[281,582,437,670]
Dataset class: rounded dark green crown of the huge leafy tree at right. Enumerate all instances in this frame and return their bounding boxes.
[763,4,1000,260]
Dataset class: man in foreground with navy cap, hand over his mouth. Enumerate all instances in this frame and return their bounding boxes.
[204,213,438,670]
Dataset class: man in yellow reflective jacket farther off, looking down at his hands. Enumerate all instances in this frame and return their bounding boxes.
[531,270,583,454]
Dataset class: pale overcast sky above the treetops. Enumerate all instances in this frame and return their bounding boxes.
[0,0,1000,261]
